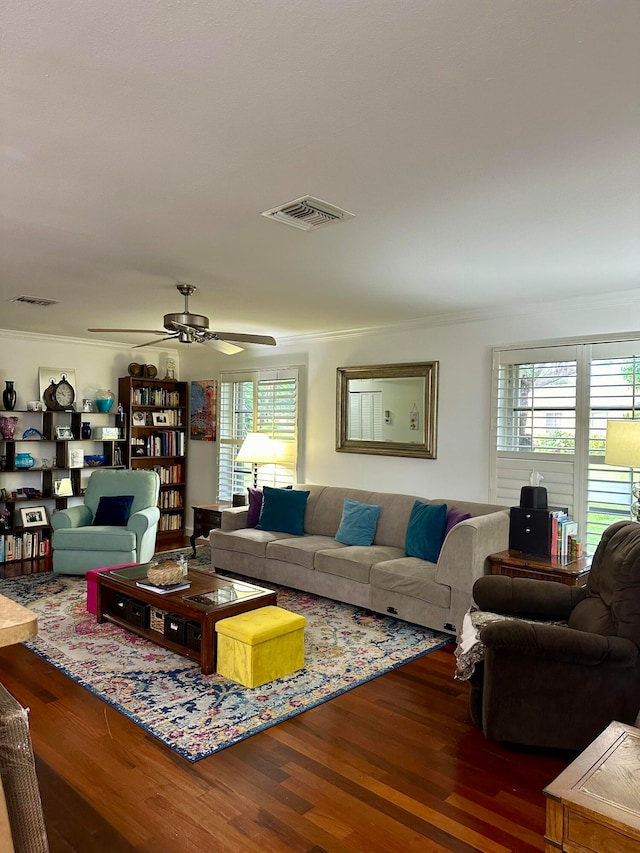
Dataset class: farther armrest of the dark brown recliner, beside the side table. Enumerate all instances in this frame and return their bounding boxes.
[473,575,586,621]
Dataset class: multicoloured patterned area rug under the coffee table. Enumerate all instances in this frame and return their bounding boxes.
[1,546,451,761]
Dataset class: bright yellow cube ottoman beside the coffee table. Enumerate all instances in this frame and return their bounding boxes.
[216,607,307,687]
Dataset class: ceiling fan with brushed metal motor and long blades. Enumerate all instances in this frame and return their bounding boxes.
[87,282,276,355]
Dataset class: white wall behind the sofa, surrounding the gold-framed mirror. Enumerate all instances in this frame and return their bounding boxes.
[181,300,640,501]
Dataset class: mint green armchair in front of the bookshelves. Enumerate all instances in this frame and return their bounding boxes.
[51,470,160,575]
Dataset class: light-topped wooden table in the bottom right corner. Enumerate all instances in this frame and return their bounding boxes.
[544,722,640,853]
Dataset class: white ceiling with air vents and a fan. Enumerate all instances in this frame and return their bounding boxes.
[0,0,640,350]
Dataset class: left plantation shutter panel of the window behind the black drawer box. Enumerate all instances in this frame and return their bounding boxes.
[490,346,580,513]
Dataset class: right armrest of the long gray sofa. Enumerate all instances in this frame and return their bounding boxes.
[436,509,509,594]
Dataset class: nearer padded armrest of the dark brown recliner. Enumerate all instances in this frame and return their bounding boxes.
[480,620,640,670]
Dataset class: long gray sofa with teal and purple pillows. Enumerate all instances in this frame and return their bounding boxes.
[209,484,509,634]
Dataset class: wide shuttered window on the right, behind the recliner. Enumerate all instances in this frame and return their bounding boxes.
[491,340,640,553]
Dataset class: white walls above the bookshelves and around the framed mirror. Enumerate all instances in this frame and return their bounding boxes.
[5,300,640,527]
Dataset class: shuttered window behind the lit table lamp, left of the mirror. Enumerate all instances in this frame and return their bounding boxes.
[218,367,299,500]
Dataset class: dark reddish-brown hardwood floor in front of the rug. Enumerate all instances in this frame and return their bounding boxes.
[0,646,574,853]
